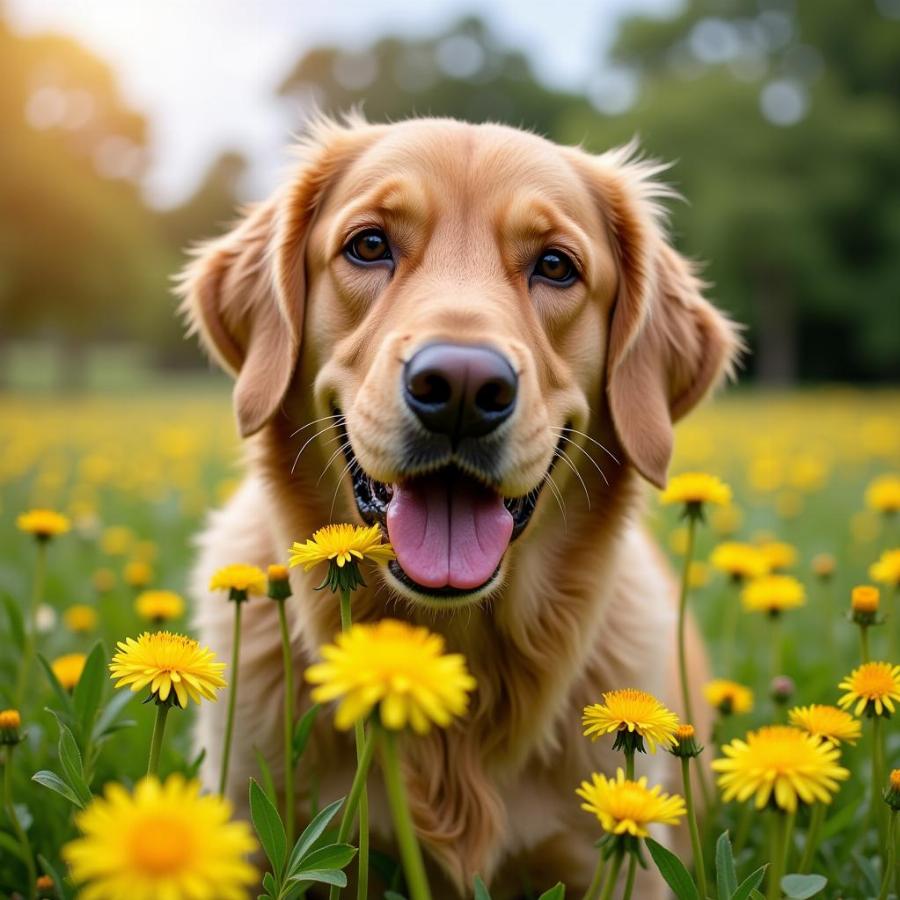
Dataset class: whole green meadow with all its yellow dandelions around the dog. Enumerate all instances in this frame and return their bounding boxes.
[0,389,900,900]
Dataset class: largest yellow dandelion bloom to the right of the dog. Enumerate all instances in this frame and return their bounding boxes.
[712,725,850,813]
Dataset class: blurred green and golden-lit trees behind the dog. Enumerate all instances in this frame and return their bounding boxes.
[0,0,900,383]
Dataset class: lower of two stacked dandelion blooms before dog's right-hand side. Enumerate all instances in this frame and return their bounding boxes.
[575,769,687,838]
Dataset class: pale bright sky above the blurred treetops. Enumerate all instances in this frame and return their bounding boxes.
[6,0,679,206]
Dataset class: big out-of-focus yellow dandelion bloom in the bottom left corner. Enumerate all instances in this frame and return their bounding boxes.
[62,775,258,900]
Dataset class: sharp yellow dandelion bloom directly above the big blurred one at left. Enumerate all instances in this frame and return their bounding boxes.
[109,631,225,709]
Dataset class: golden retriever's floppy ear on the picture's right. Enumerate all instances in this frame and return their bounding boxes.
[576,146,740,487]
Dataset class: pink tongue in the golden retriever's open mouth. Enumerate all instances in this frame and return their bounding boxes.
[387,476,513,590]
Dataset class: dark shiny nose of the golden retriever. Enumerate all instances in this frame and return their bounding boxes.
[403,344,518,441]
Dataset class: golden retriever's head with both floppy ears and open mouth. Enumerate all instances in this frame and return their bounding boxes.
[182,119,736,603]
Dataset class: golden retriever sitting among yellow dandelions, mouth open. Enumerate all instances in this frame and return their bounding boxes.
[178,116,740,900]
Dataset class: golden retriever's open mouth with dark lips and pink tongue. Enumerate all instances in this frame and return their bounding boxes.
[338,420,569,599]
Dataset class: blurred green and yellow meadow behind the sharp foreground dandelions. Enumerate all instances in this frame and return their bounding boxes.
[0,389,900,898]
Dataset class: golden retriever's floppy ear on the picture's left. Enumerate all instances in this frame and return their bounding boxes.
[176,117,375,437]
